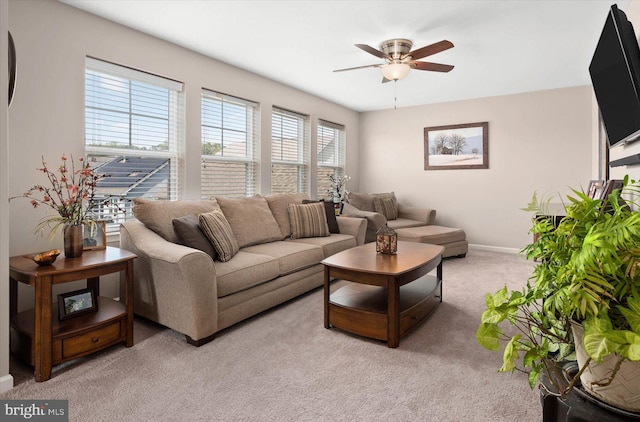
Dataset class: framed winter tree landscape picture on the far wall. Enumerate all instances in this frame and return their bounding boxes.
[424,122,489,170]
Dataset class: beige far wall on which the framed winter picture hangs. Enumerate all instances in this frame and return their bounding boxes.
[359,86,593,249]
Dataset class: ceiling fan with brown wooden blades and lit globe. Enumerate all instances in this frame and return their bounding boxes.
[334,38,453,83]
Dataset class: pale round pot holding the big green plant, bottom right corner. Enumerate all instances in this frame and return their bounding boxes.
[571,323,640,412]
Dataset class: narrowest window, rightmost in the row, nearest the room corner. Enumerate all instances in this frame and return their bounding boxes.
[316,120,345,200]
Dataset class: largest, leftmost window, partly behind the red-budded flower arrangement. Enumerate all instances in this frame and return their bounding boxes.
[85,58,184,232]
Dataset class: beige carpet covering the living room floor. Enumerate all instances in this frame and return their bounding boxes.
[0,250,541,422]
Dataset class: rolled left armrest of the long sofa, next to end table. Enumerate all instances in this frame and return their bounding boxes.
[120,220,218,340]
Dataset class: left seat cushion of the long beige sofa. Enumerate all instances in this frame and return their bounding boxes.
[216,251,279,297]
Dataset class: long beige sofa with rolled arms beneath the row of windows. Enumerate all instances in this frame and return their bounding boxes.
[120,194,366,346]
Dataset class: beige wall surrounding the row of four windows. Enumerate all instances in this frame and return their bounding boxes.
[3,0,359,309]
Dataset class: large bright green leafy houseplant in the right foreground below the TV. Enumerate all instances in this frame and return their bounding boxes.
[476,177,640,411]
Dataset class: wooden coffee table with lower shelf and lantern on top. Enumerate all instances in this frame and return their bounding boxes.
[322,242,444,347]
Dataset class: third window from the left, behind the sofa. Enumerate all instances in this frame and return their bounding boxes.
[271,108,309,193]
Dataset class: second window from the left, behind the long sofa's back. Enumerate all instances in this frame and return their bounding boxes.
[200,90,259,199]
